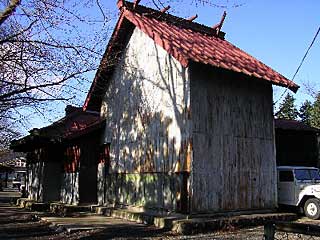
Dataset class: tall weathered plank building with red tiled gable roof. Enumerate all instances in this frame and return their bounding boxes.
[84,1,298,213]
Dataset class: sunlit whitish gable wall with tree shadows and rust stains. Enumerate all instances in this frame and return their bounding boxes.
[98,29,191,209]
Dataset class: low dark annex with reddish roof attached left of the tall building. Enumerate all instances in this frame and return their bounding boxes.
[11,106,103,204]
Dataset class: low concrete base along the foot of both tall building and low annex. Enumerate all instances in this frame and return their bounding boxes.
[17,199,298,235]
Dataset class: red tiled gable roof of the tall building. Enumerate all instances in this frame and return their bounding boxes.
[84,1,299,110]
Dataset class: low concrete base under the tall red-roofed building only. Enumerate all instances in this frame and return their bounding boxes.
[95,207,298,235]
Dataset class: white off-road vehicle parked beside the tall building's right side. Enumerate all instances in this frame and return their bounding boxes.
[277,166,320,219]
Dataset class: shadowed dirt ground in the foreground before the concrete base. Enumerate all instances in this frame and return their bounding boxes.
[0,192,320,240]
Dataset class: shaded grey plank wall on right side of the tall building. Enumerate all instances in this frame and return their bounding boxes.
[190,64,277,212]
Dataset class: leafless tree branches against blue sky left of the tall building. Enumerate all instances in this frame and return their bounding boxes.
[0,0,110,146]
